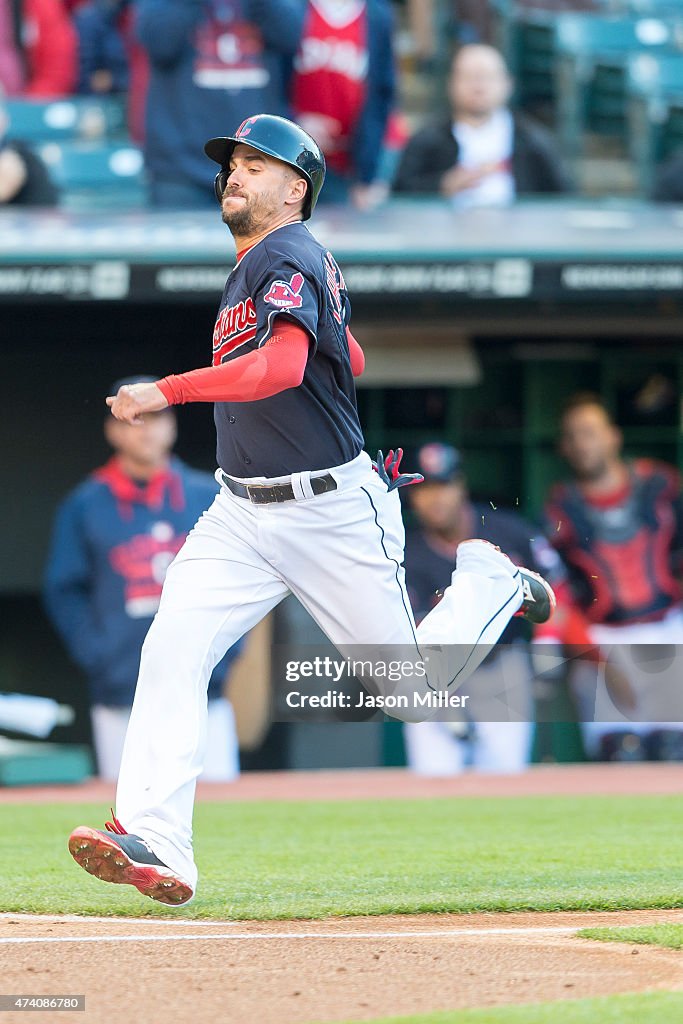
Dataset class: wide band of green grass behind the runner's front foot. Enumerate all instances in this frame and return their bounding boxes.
[0,797,683,919]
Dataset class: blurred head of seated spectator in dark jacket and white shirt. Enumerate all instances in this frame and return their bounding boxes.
[449,45,511,117]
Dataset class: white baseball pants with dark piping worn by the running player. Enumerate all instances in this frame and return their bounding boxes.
[117,452,522,889]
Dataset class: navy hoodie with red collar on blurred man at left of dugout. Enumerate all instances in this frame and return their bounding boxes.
[45,458,241,708]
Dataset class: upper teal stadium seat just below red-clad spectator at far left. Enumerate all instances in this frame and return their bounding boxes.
[5,96,126,142]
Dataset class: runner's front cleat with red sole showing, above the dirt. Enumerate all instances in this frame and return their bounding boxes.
[69,818,194,906]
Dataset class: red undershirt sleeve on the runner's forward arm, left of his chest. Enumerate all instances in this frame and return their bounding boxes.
[157,317,310,406]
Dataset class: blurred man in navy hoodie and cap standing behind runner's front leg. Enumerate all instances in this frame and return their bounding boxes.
[45,377,239,780]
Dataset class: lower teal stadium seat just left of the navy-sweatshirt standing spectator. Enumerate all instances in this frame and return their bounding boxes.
[38,142,145,209]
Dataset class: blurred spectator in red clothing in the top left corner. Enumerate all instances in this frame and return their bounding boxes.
[0,0,78,99]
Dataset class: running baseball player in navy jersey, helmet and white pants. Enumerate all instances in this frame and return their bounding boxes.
[69,114,554,905]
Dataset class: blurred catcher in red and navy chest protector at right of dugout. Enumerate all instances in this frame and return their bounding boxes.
[547,393,683,761]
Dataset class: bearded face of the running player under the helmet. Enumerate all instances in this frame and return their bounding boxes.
[221,143,306,238]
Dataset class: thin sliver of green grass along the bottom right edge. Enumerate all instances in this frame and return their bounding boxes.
[317,992,683,1024]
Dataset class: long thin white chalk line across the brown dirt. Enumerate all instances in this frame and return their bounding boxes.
[0,918,579,945]
